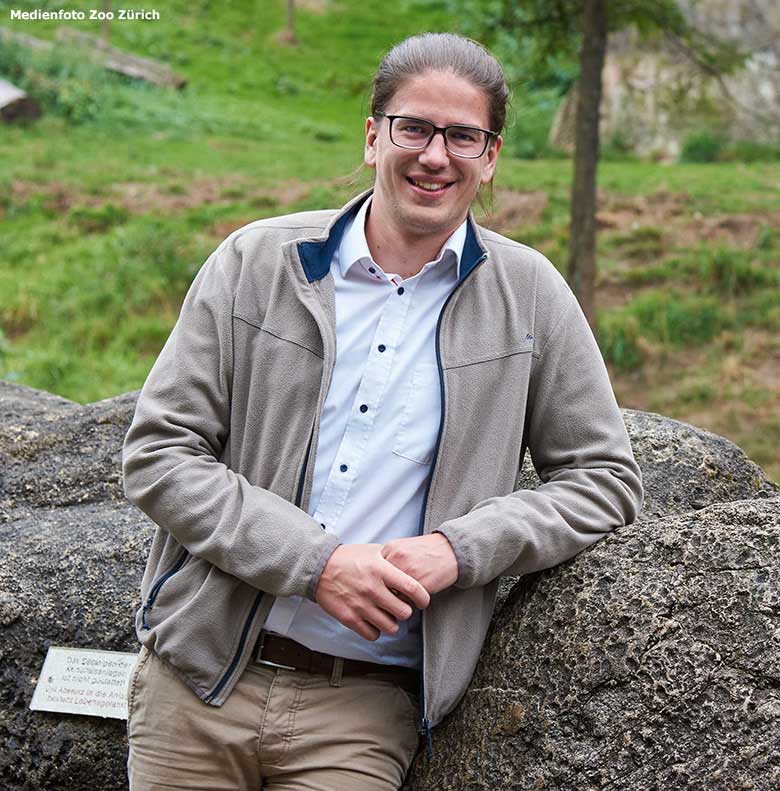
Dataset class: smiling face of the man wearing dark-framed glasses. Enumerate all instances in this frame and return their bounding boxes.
[365,71,502,244]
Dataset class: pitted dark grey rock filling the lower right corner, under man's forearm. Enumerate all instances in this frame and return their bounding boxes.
[410,497,780,791]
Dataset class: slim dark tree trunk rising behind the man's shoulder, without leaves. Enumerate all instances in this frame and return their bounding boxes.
[568,0,607,330]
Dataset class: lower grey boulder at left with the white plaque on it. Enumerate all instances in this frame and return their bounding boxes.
[0,502,152,791]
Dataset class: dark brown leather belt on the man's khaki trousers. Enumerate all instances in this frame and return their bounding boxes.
[254,632,420,695]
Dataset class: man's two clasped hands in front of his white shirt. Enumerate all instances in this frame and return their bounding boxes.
[314,533,458,640]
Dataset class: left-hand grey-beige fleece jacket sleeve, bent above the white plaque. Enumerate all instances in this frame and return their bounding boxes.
[122,239,340,599]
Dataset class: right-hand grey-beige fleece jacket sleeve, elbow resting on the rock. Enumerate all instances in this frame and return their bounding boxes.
[437,286,643,588]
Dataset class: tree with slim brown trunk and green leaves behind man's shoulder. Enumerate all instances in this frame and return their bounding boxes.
[452,0,739,329]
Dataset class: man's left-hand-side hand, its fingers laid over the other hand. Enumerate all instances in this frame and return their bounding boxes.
[314,544,431,640]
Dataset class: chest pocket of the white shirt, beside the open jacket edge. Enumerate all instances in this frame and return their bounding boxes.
[393,363,441,464]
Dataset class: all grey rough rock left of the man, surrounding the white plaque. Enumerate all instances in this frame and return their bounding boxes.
[0,382,152,791]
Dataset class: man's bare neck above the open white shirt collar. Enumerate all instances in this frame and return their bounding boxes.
[365,203,455,278]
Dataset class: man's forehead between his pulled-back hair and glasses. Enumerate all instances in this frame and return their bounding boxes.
[385,71,490,129]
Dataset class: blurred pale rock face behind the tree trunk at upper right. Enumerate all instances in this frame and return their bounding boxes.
[550,0,780,158]
